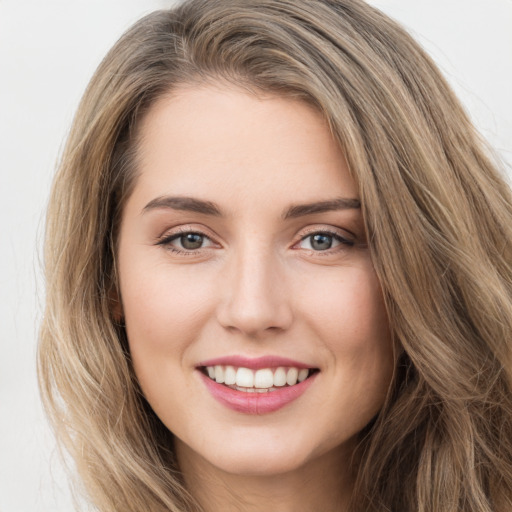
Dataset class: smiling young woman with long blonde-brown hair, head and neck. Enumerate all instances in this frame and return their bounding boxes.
[39,0,512,512]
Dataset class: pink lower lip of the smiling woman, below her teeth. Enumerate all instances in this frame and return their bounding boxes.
[199,372,318,414]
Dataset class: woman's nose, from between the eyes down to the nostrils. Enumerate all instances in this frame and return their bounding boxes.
[217,243,293,337]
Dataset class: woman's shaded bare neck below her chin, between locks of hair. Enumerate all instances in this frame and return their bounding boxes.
[176,441,353,512]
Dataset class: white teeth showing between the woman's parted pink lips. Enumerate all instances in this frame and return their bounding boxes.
[199,365,319,393]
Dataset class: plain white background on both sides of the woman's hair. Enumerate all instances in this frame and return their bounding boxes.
[0,0,512,512]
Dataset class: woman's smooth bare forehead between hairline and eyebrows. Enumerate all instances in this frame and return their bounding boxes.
[130,85,358,213]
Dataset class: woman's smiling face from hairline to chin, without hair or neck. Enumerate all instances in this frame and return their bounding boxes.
[118,85,393,474]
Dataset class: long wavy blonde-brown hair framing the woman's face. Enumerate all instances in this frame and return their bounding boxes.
[38,0,512,512]
